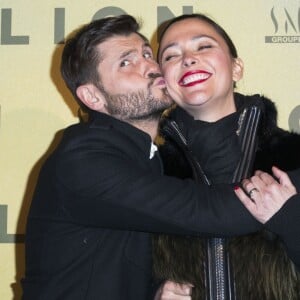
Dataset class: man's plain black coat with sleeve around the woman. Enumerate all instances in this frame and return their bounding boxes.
[23,113,260,300]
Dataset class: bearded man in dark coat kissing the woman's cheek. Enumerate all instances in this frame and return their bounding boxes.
[23,16,298,300]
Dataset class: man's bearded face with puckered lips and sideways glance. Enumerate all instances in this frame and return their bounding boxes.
[97,33,172,121]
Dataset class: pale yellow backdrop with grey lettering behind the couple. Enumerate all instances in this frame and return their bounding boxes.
[0,0,300,300]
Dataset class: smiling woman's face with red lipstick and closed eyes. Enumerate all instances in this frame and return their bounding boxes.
[159,18,243,119]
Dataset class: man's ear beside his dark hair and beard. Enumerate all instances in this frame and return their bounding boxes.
[76,83,105,111]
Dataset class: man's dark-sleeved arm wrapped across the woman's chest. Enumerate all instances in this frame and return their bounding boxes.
[57,144,260,236]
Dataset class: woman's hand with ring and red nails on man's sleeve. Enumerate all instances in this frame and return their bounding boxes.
[235,167,297,224]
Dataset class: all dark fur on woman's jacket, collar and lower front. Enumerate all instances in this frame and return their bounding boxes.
[153,94,300,300]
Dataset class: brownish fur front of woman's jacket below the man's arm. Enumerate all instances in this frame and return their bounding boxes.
[153,232,300,300]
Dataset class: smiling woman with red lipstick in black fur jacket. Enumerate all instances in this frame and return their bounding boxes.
[154,14,300,300]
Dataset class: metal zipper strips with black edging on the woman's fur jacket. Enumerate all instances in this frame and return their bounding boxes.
[164,106,261,300]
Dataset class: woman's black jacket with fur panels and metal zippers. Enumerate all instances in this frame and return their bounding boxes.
[154,94,300,300]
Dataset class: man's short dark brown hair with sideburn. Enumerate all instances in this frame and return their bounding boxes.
[60,15,146,109]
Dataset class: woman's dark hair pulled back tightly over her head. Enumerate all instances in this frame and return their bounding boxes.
[157,13,238,58]
